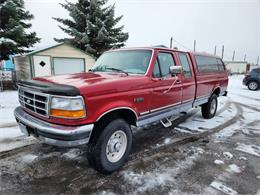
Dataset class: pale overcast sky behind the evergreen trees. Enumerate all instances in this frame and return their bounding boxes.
[25,0,260,63]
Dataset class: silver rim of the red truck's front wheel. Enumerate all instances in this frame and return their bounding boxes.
[106,130,127,163]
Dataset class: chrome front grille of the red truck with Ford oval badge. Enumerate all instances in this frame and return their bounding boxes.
[19,87,49,117]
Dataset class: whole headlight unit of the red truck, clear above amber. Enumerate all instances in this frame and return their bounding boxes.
[50,97,86,119]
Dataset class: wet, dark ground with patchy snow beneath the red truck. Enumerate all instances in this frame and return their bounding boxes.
[0,76,260,194]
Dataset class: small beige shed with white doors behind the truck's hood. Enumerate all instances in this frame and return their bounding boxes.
[14,43,95,80]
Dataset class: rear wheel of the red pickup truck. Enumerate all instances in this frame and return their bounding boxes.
[201,94,218,119]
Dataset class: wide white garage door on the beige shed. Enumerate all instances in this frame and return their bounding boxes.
[53,58,85,75]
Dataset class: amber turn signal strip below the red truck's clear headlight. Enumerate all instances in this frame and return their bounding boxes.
[51,109,85,119]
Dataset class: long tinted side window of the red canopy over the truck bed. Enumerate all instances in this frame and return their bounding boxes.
[195,55,220,72]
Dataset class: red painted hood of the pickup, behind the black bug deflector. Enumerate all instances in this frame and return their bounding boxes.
[34,72,145,96]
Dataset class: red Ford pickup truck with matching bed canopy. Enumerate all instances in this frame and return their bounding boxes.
[14,47,228,173]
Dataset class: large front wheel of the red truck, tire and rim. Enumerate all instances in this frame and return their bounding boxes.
[87,119,132,174]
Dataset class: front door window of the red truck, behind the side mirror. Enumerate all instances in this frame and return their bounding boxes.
[158,52,175,77]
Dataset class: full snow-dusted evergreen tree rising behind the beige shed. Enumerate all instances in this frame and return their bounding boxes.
[54,0,128,57]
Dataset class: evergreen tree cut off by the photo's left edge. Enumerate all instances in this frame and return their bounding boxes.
[0,0,40,61]
